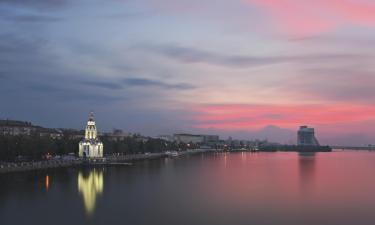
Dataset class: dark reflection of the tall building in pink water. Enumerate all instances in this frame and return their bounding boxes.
[298,152,316,194]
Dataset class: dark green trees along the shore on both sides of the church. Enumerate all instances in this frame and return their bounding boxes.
[0,135,197,161]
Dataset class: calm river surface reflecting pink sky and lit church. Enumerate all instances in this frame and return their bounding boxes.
[0,151,375,225]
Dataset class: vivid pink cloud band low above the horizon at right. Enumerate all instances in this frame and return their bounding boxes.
[194,104,375,134]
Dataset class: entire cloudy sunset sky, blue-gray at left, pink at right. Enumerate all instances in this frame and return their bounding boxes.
[0,0,375,145]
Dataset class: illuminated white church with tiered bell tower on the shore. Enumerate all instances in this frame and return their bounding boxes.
[78,112,103,158]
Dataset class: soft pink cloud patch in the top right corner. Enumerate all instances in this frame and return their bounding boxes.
[244,0,375,35]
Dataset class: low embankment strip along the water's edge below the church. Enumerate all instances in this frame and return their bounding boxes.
[0,149,218,174]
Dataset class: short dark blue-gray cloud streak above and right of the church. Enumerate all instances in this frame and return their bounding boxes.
[123,78,195,90]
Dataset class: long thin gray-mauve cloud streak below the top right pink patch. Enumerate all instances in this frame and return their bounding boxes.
[142,45,369,67]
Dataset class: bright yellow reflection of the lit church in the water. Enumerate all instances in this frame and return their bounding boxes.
[78,169,103,216]
